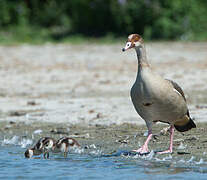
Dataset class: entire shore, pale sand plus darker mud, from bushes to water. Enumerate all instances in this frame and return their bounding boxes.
[0,43,207,159]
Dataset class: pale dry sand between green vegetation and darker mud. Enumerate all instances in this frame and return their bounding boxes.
[0,43,207,125]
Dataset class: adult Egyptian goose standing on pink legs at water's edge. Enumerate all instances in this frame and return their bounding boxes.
[122,34,196,154]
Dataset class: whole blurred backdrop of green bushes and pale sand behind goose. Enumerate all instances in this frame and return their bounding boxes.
[0,0,207,125]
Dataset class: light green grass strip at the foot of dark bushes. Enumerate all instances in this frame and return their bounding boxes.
[0,26,207,45]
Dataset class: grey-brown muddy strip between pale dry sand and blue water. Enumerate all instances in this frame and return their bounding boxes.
[0,122,207,161]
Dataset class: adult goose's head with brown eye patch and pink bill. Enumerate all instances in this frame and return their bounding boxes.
[122,34,143,52]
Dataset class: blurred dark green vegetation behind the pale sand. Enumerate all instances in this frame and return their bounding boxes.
[0,0,207,44]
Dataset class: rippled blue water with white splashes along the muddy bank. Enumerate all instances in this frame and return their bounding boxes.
[0,136,207,180]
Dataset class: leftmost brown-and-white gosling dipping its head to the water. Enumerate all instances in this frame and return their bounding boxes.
[24,137,56,158]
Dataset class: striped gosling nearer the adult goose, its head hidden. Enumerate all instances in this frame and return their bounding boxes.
[54,137,80,157]
